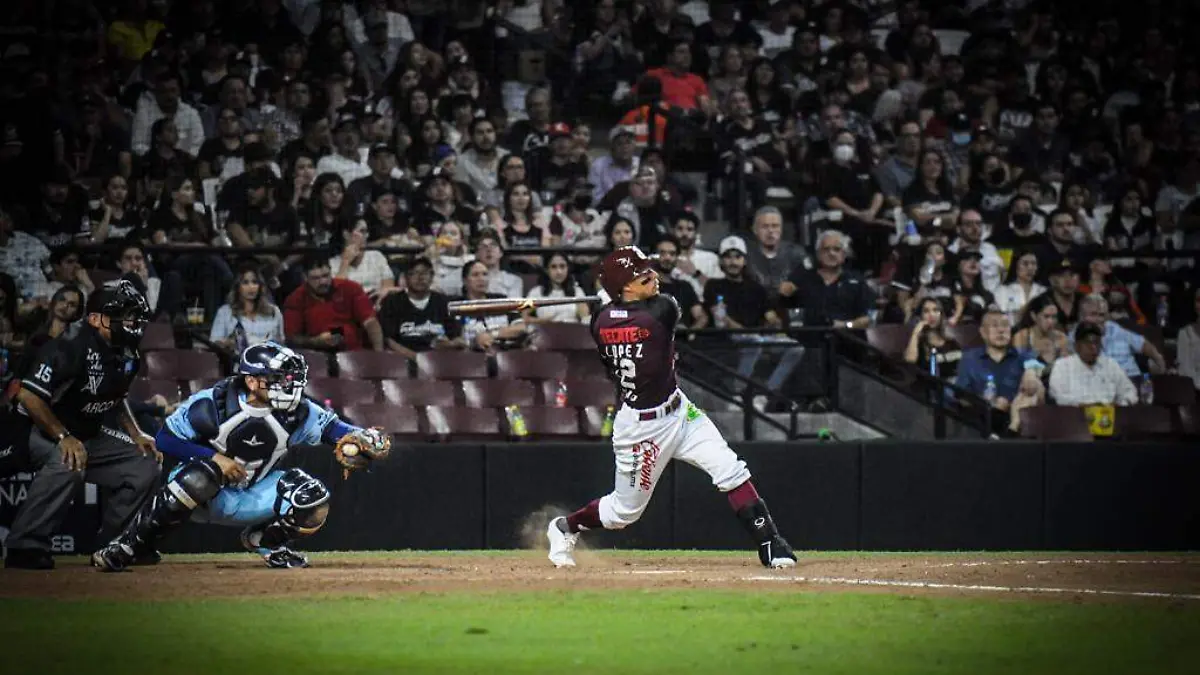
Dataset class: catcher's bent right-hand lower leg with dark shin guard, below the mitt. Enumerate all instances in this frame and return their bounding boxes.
[241,468,332,567]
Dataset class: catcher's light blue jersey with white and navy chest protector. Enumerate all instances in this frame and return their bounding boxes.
[167,377,337,485]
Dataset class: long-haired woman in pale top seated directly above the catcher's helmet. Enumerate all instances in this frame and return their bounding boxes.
[209,264,284,354]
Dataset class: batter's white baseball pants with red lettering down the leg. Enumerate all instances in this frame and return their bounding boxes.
[600,389,750,530]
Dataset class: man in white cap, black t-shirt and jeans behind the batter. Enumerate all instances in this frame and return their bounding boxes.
[704,235,804,410]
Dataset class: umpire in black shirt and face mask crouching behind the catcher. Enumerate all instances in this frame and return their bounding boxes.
[5,281,161,569]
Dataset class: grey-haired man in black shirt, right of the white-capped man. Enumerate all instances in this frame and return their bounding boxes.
[779,229,875,330]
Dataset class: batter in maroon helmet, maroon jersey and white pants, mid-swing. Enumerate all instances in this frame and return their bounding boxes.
[546,246,796,567]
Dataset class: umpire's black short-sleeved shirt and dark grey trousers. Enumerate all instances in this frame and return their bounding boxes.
[6,285,160,568]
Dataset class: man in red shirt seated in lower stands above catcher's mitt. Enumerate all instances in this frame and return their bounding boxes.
[283,256,383,352]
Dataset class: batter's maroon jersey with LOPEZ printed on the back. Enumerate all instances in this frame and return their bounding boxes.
[592,293,679,410]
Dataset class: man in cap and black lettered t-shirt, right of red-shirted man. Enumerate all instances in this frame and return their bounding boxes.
[379,257,467,359]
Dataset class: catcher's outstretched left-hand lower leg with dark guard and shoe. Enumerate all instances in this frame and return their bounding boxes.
[91,460,224,572]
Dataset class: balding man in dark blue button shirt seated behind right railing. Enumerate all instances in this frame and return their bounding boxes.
[954,309,1034,412]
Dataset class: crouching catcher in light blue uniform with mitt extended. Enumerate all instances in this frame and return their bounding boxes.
[91,342,391,572]
